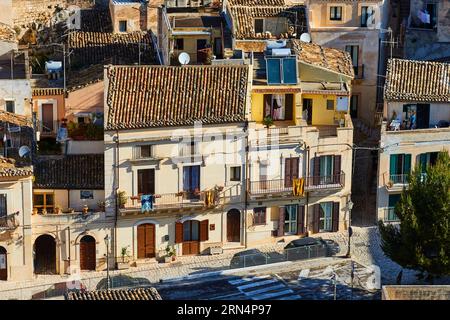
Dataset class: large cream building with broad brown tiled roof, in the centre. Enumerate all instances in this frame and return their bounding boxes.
[104,65,251,264]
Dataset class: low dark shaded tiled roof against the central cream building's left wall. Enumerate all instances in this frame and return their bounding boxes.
[34,154,105,189]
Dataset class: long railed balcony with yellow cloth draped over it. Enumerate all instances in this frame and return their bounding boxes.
[248,171,345,197]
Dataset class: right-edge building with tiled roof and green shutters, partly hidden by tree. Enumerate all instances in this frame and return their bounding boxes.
[377,59,450,222]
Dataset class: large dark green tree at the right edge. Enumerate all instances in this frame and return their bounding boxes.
[378,151,450,280]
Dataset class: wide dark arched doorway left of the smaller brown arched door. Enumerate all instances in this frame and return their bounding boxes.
[34,234,56,274]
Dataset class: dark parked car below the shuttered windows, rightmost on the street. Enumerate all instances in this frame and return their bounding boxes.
[284,237,340,260]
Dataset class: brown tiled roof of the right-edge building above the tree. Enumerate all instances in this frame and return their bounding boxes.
[384,59,450,102]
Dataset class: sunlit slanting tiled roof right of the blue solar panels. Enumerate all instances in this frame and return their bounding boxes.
[290,39,355,78]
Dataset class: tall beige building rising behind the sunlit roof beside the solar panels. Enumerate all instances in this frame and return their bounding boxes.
[307,0,387,126]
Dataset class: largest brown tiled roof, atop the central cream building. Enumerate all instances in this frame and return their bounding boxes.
[106,65,249,130]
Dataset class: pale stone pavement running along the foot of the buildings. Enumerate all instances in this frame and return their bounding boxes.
[0,227,448,299]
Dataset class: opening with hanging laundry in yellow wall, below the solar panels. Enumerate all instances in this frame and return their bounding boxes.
[264,94,294,120]
